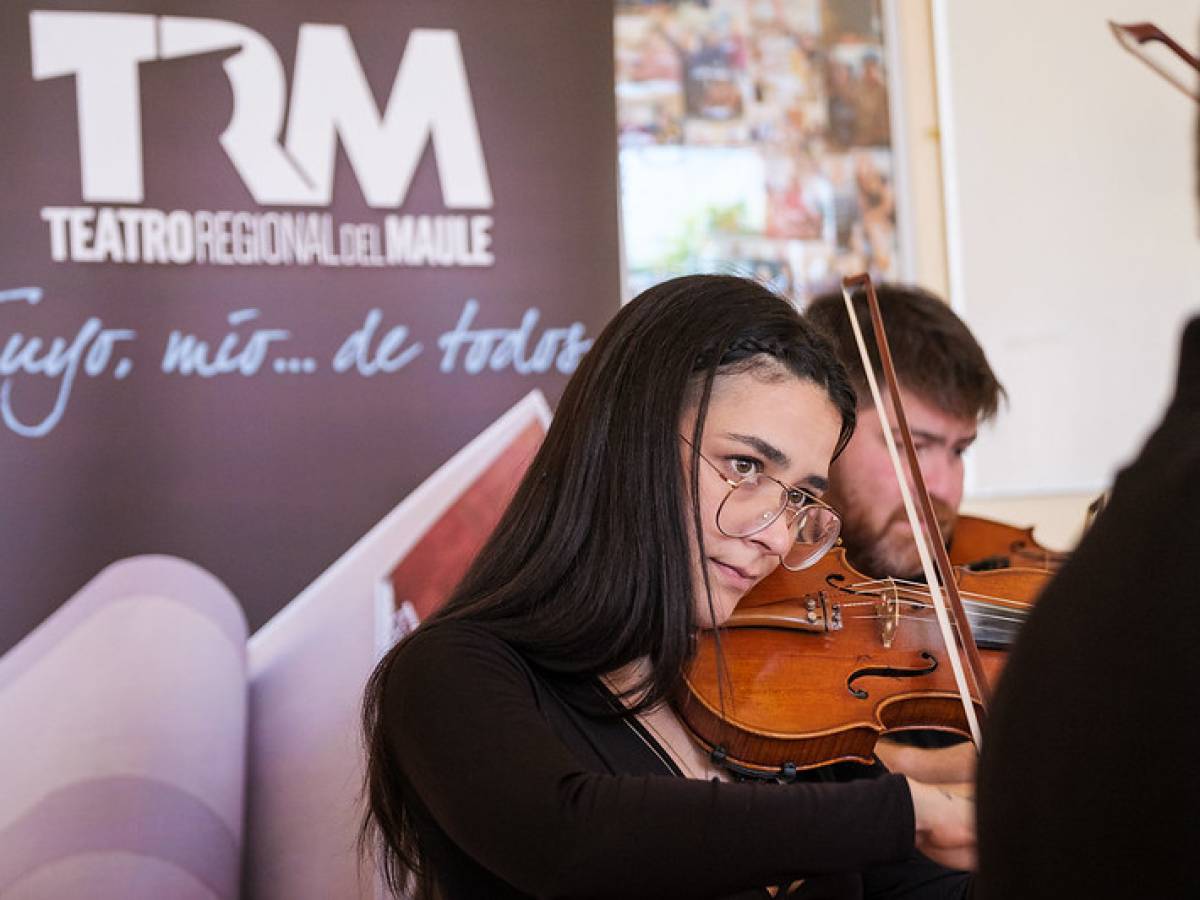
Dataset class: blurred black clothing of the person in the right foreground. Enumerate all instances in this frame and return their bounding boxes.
[978,317,1200,900]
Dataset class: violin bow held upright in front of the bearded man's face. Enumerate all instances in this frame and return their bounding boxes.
[841,272,991,749]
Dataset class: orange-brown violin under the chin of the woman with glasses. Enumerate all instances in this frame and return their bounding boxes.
[676,548,1050,780]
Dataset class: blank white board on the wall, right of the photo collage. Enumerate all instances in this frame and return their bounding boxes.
[936,0,1200,498]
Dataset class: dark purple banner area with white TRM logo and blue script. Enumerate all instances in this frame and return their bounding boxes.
[0,0,619,653]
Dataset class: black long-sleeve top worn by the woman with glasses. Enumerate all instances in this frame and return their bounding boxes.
[384,623,967,900]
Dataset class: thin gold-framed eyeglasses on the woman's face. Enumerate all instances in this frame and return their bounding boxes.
[680,436,841,572]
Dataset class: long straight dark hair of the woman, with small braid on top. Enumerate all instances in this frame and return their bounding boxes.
[360,275,854,898]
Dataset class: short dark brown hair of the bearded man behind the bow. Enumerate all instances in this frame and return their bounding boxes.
[805,284,1004,420]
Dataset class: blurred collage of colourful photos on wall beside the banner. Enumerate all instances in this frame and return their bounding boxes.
[616,0,899,305]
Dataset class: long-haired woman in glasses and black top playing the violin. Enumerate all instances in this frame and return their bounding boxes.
[364,276,973,900]
